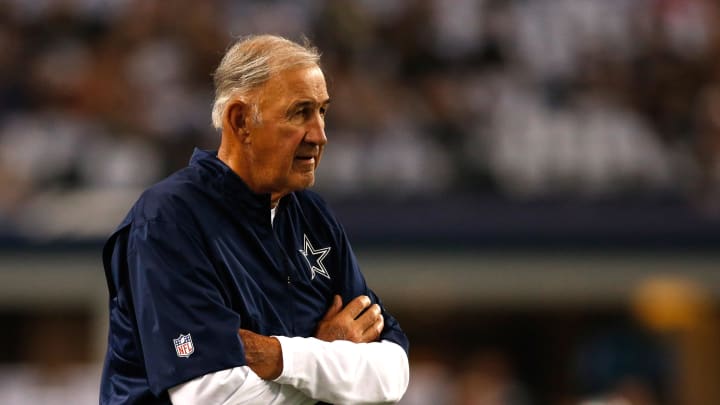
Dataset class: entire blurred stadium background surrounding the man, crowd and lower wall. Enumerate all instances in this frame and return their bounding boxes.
[0,0,720,405]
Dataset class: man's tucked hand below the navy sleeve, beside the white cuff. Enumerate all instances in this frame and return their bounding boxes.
[238,329,283,380]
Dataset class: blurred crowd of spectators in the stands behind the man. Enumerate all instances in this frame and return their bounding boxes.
[0,0,720,235]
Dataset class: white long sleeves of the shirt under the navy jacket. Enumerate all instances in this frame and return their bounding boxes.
[169,336,410,405]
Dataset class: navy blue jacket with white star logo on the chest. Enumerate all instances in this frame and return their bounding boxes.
[100,150,408,404]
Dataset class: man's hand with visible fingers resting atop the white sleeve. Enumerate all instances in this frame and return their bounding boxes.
[315,295,385,343]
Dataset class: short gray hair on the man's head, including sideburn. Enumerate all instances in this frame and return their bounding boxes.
[212,35,320,129]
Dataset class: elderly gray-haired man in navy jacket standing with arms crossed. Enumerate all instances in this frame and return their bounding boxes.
[100,35,409,404]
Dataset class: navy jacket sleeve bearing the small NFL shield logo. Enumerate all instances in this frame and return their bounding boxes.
[126,220,245,395]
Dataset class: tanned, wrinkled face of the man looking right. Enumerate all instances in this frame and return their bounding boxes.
[247,66,329,200]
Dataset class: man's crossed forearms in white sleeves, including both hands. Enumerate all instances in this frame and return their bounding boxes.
[169,295,409,404]
